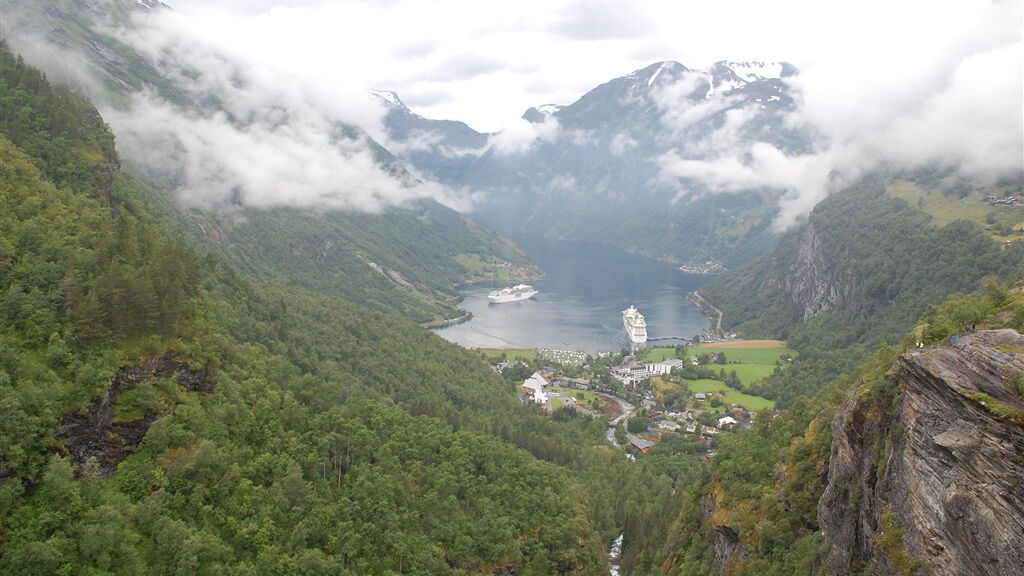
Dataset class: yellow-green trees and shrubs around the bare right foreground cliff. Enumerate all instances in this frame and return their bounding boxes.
[651,281,1024,576]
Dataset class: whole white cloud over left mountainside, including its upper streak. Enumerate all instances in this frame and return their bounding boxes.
[94,6,468,212]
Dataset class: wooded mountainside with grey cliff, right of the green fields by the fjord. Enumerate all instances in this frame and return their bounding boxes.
[700,177,1024,402]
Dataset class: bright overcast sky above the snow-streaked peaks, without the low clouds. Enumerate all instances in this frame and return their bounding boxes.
[159,0,1024,131]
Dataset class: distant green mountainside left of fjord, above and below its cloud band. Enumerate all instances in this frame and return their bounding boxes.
[4,0,540,324]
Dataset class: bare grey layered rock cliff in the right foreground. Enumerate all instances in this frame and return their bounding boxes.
[818,330,1024,575]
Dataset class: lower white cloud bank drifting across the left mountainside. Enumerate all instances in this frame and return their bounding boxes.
[105,94,459,212]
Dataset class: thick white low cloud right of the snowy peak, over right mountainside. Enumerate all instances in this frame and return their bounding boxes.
[652,12,1024,230]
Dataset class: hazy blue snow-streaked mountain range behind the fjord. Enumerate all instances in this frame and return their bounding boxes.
[378,61,811,265]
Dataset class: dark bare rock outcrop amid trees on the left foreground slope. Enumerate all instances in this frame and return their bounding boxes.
[60,352,213,475]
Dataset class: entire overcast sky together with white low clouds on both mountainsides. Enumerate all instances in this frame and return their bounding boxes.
[9,0,1024,218]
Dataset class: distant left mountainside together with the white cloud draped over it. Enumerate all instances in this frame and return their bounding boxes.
[3,0,536,323]
